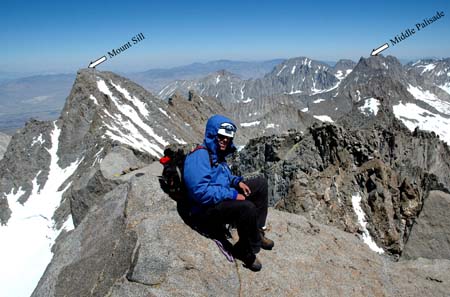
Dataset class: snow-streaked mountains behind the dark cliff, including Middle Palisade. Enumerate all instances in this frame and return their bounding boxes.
[158,56,450,143]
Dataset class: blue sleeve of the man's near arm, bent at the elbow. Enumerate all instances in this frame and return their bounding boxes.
[184,150,238,205]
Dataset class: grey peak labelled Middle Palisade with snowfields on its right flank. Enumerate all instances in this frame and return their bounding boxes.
[286,56,450,143]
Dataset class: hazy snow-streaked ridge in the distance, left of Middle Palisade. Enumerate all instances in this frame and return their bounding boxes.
[158,57,354,106]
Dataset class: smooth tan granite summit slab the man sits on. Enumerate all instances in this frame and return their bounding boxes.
[32,158,450,297]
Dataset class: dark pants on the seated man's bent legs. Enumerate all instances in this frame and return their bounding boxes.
[192,177,268,255]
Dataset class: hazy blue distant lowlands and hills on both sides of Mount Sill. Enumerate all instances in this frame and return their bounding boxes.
[0,59,283,134]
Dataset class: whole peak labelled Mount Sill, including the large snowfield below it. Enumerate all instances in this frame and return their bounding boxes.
[0,70,229,296]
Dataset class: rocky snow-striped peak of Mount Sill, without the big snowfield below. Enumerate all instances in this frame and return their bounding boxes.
[0,70,224,224]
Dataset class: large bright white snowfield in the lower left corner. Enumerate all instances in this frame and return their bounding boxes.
[0,123,82,296]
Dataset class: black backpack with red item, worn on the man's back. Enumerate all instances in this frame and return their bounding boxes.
[159,145,211,202]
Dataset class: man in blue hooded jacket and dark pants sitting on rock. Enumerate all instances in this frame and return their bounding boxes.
[184,115,274,271]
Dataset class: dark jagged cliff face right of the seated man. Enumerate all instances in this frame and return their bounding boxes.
[234,104,450,257]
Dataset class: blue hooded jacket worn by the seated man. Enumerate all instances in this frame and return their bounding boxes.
[184,115,243,205]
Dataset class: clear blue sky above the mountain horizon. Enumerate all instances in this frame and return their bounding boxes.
[0,0,450,72]
